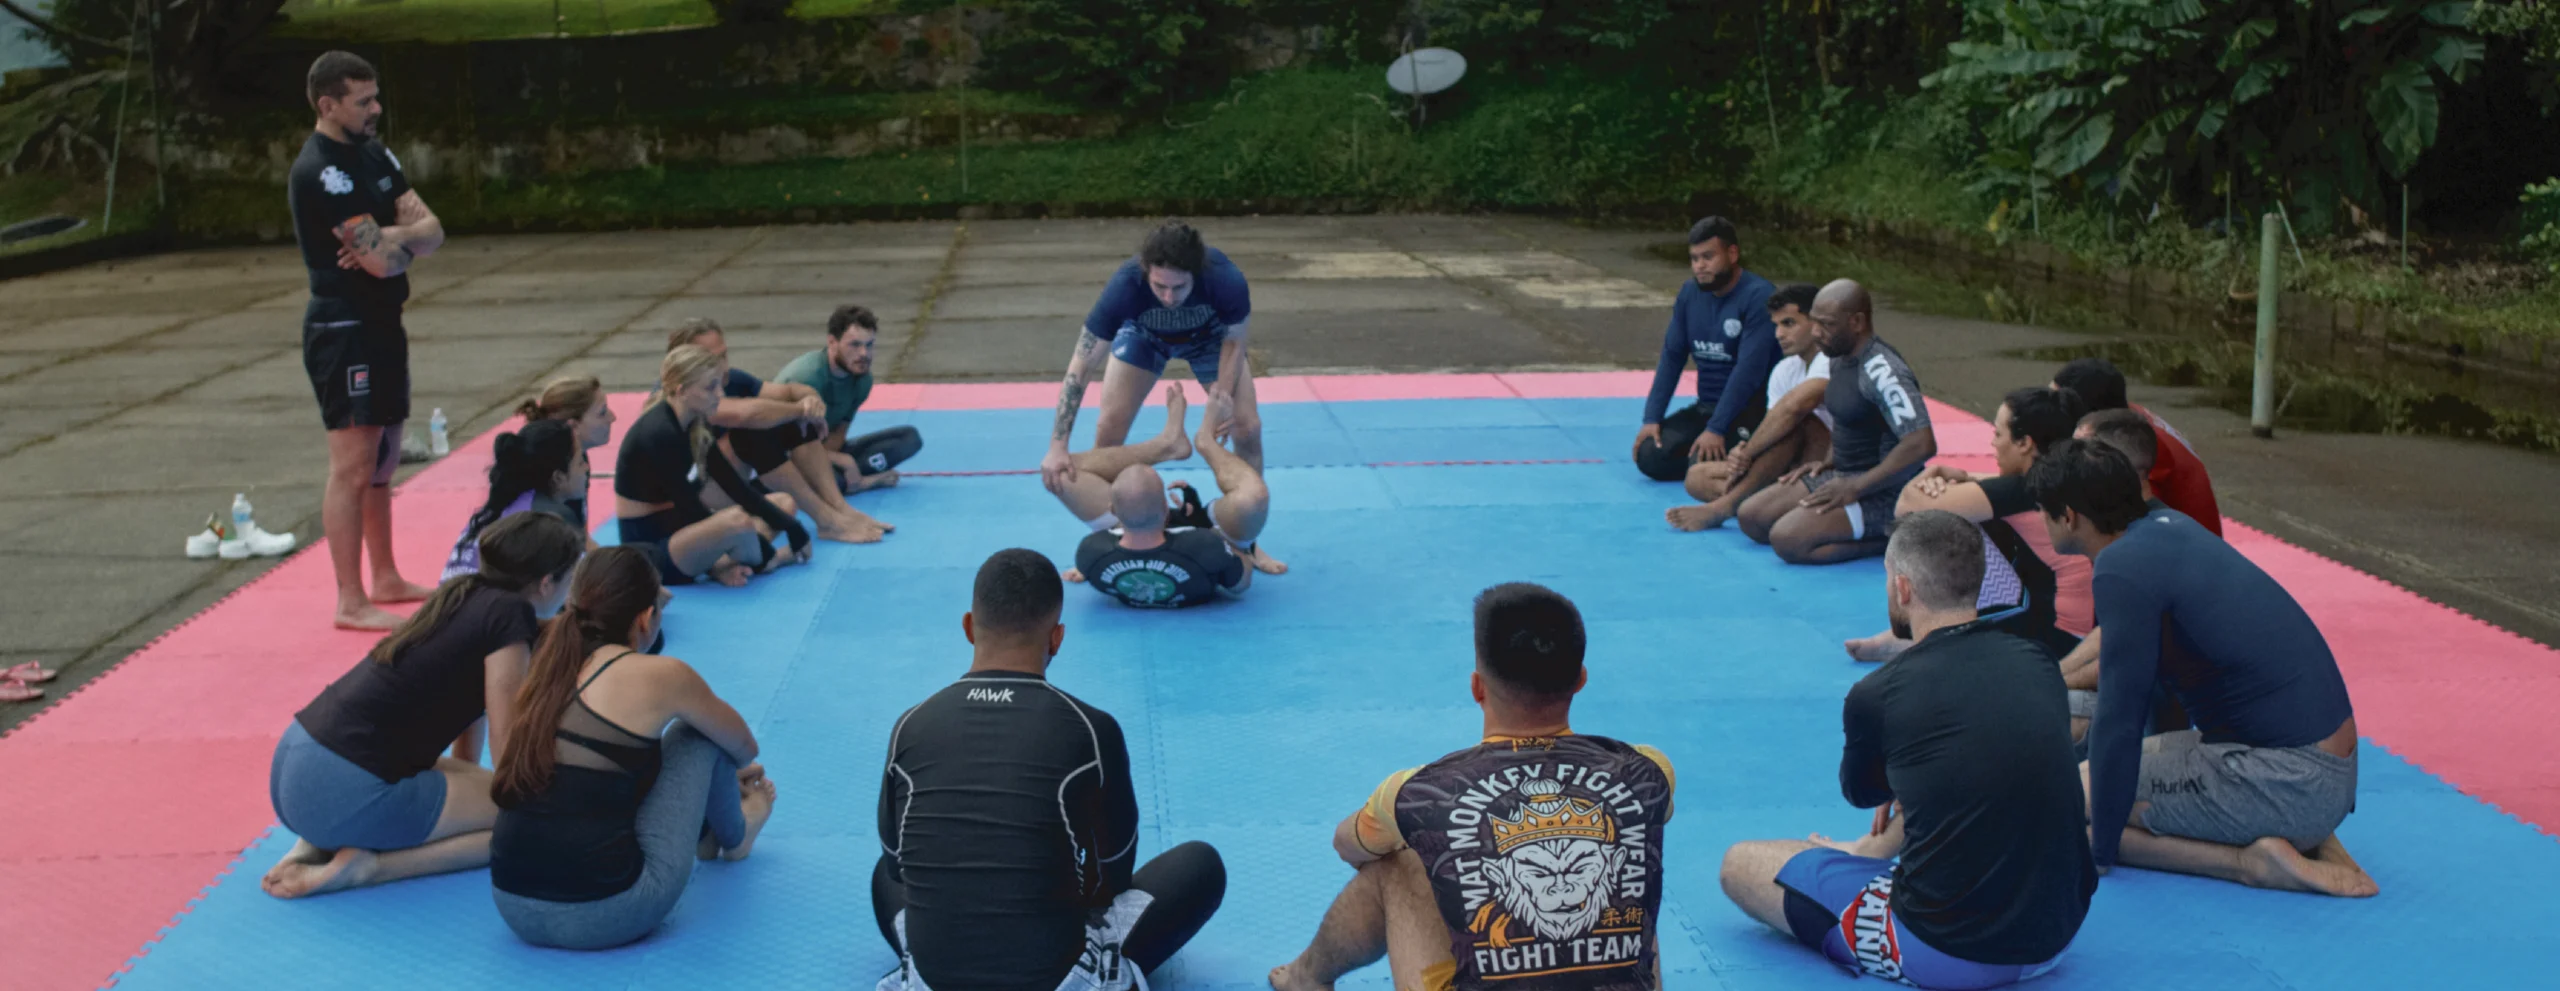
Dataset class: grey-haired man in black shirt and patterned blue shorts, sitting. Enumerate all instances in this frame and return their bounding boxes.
[1723,510,2097,991]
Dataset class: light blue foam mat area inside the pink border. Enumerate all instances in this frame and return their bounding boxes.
[118,399,2560,991]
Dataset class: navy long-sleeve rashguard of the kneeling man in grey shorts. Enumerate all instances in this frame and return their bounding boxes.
[2089,510,2355,866]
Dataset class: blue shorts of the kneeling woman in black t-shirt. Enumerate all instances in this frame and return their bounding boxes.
[266,720,445,850]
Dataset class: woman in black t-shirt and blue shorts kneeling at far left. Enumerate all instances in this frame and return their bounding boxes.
[259,512,586,899]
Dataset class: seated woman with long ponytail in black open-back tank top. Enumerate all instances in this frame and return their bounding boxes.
[489,548,773,950]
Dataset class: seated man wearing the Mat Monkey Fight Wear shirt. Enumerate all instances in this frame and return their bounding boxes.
[1270,584,1674,991]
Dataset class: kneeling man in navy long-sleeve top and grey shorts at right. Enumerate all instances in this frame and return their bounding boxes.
[2028,440,2378,896]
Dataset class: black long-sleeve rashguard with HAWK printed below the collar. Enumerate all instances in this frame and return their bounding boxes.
[881,671,1137,991]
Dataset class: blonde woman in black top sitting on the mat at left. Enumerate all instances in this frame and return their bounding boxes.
[614,346,809,586]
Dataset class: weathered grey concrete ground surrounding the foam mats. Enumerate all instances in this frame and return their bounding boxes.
[0,215,2560,727]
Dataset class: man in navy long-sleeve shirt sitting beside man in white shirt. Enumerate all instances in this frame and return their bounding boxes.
[1636,218,1779,481]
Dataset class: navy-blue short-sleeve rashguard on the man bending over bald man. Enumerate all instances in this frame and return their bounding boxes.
[1085,248,1254,384]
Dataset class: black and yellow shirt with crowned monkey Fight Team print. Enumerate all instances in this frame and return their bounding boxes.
[1395,735,1672,991]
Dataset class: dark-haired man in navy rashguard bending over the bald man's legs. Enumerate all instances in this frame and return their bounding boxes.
[1039,220,1288,574]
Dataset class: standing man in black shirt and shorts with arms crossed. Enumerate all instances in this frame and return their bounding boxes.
[284,51,445,630]
